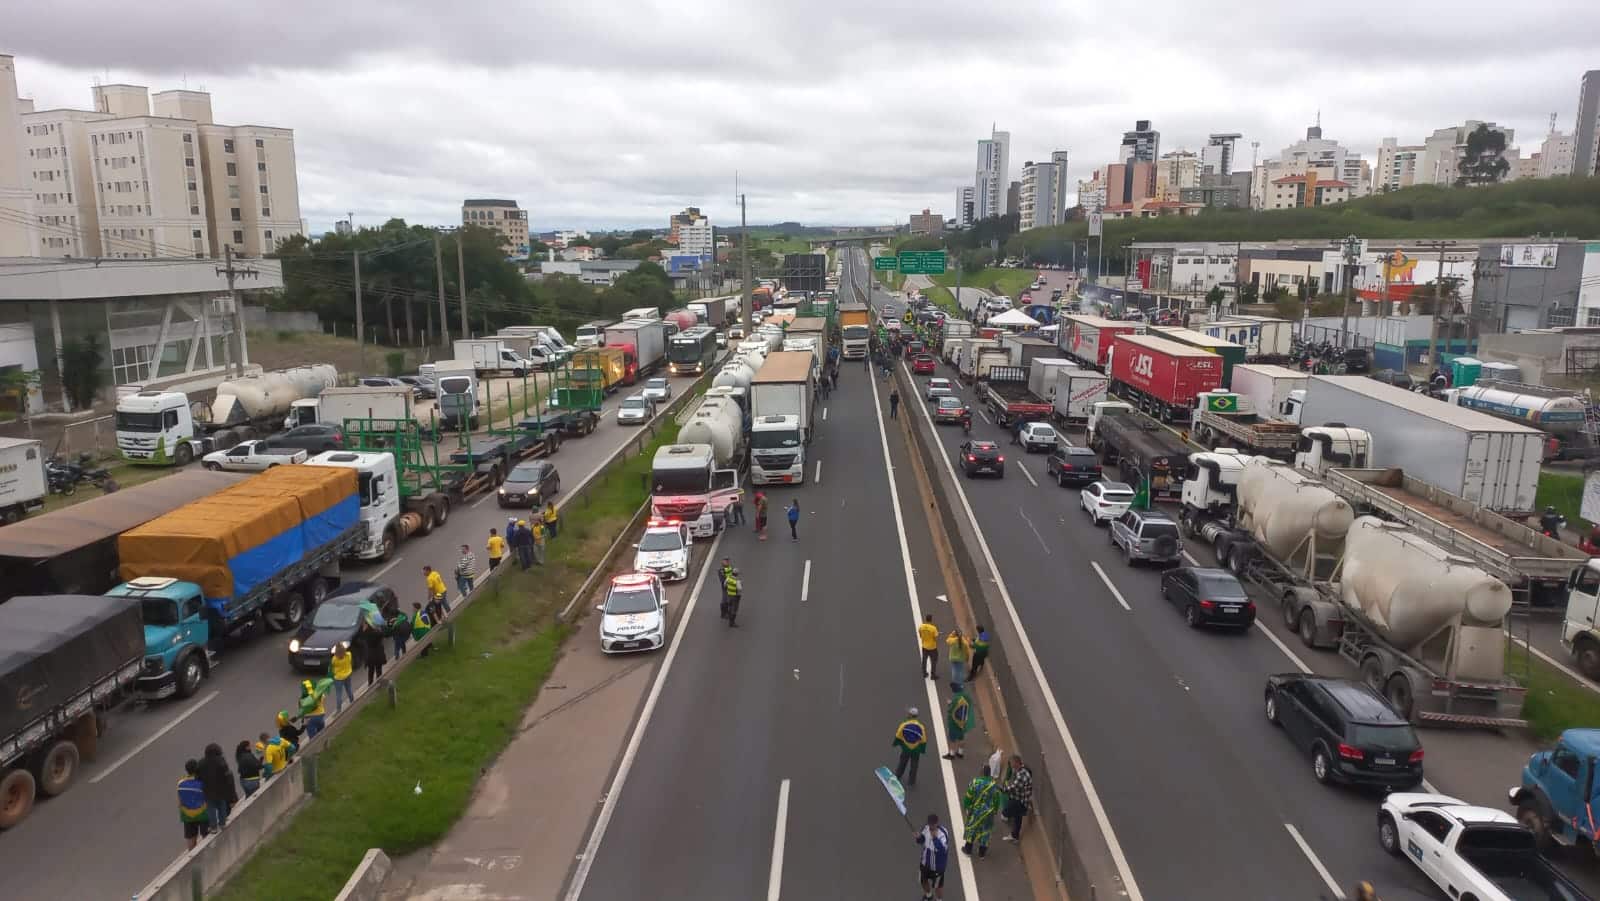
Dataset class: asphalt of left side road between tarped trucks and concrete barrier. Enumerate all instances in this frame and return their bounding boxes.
[0,379,690,898]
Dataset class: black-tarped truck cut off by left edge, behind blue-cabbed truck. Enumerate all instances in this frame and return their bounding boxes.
[0,594,144,829]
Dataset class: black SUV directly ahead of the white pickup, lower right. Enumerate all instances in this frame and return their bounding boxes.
[1266,672,1422,791]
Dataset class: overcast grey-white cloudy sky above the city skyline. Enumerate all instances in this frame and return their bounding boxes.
[0,0,1600,234]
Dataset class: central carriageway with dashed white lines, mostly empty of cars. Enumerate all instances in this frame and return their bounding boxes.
[568,256,1030,899]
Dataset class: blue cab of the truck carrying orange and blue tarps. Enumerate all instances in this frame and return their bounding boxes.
[106,576,221,699]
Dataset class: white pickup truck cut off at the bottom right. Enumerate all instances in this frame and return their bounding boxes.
[1378,792,1589,901]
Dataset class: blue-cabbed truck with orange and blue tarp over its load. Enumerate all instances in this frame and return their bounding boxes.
[107,466,363,699]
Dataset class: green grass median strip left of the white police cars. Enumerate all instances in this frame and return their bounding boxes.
[216,418,678,901]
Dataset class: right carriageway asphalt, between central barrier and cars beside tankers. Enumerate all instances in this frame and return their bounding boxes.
[874,265,1452,901]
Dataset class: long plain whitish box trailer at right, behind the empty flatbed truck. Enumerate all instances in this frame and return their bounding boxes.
[1301,376,1544,517]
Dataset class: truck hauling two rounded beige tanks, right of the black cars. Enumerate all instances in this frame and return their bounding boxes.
[1181,455,1526,728]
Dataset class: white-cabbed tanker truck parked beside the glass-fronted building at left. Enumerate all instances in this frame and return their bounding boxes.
[117,363,338,466]
